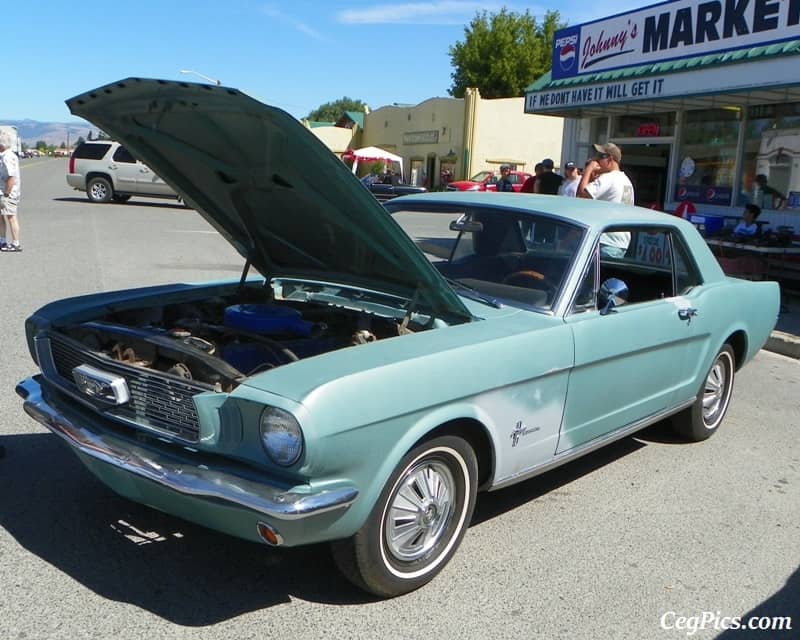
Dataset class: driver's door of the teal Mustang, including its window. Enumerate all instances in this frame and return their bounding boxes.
[557,228,694,453]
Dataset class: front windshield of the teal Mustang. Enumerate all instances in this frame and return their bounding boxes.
[392,205,585,309]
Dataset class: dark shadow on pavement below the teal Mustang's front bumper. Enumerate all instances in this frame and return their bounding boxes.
[0,433,374,627]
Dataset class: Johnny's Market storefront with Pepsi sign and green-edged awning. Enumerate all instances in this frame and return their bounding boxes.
[525,0,800,234]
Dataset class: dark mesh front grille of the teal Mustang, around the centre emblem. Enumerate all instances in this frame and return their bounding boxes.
[43,334,214,442]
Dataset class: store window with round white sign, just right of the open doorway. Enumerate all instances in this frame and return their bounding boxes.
[675,107,741,206]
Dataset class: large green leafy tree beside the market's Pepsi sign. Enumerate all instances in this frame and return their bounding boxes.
[448,8,567,98]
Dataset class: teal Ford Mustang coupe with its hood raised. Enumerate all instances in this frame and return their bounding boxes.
[17,78,779,596]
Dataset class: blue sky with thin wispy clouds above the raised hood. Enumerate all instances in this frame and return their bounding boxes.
[7,0,653,122]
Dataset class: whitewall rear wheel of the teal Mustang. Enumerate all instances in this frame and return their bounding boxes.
[672,344,736,442]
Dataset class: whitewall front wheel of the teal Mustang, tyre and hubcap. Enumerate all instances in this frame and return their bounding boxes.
[332,436,478,598]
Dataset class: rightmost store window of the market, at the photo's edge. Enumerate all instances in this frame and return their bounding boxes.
[737,102,800,210]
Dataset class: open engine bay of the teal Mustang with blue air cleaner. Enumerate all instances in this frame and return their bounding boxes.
[60,289,425,392]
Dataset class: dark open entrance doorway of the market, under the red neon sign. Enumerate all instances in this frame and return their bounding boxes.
[619,142,672,211]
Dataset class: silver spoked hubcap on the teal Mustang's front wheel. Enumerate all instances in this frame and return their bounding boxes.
[384,460,456,562]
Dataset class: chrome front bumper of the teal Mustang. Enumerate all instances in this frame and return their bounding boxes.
[16,378,358,520]
